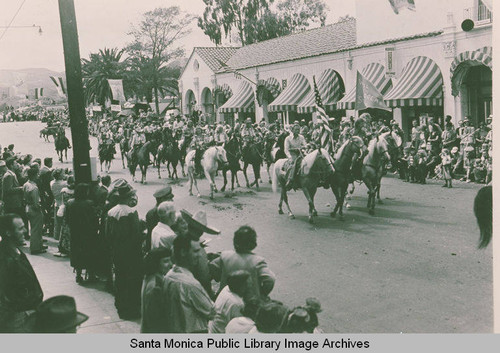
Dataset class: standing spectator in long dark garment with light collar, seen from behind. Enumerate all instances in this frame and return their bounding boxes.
[106,179,142,320]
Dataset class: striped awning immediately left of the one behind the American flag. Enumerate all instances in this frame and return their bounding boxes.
[268,74,311,112]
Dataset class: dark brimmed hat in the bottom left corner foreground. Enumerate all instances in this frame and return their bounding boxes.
[26,295,89,333]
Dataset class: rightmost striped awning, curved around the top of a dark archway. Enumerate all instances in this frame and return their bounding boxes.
[450,47,493,96]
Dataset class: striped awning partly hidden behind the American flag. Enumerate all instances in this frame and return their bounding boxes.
[297,69,345,113]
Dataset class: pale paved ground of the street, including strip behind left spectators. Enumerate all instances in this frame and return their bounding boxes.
[0,122,493,333]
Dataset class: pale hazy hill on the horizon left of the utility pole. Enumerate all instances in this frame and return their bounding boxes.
[0,68,65,104]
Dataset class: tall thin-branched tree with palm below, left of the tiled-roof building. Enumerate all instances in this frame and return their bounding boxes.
[126,6,194,112]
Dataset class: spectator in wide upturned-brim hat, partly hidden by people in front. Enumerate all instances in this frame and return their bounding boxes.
[181,210,220,298]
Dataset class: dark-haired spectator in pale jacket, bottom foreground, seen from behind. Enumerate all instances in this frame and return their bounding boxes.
[162,236,215,333]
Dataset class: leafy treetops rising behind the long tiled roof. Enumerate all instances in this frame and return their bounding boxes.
[198,0,327,45]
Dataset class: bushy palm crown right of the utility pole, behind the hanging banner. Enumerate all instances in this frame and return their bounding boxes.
[82,48,131,105]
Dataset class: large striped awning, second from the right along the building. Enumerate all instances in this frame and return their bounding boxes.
[384,56,443,107]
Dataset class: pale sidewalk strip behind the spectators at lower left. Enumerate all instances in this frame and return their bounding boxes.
[23,237,140,333]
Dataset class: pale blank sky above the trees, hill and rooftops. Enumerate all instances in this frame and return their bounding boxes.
[0,0,355,71]
